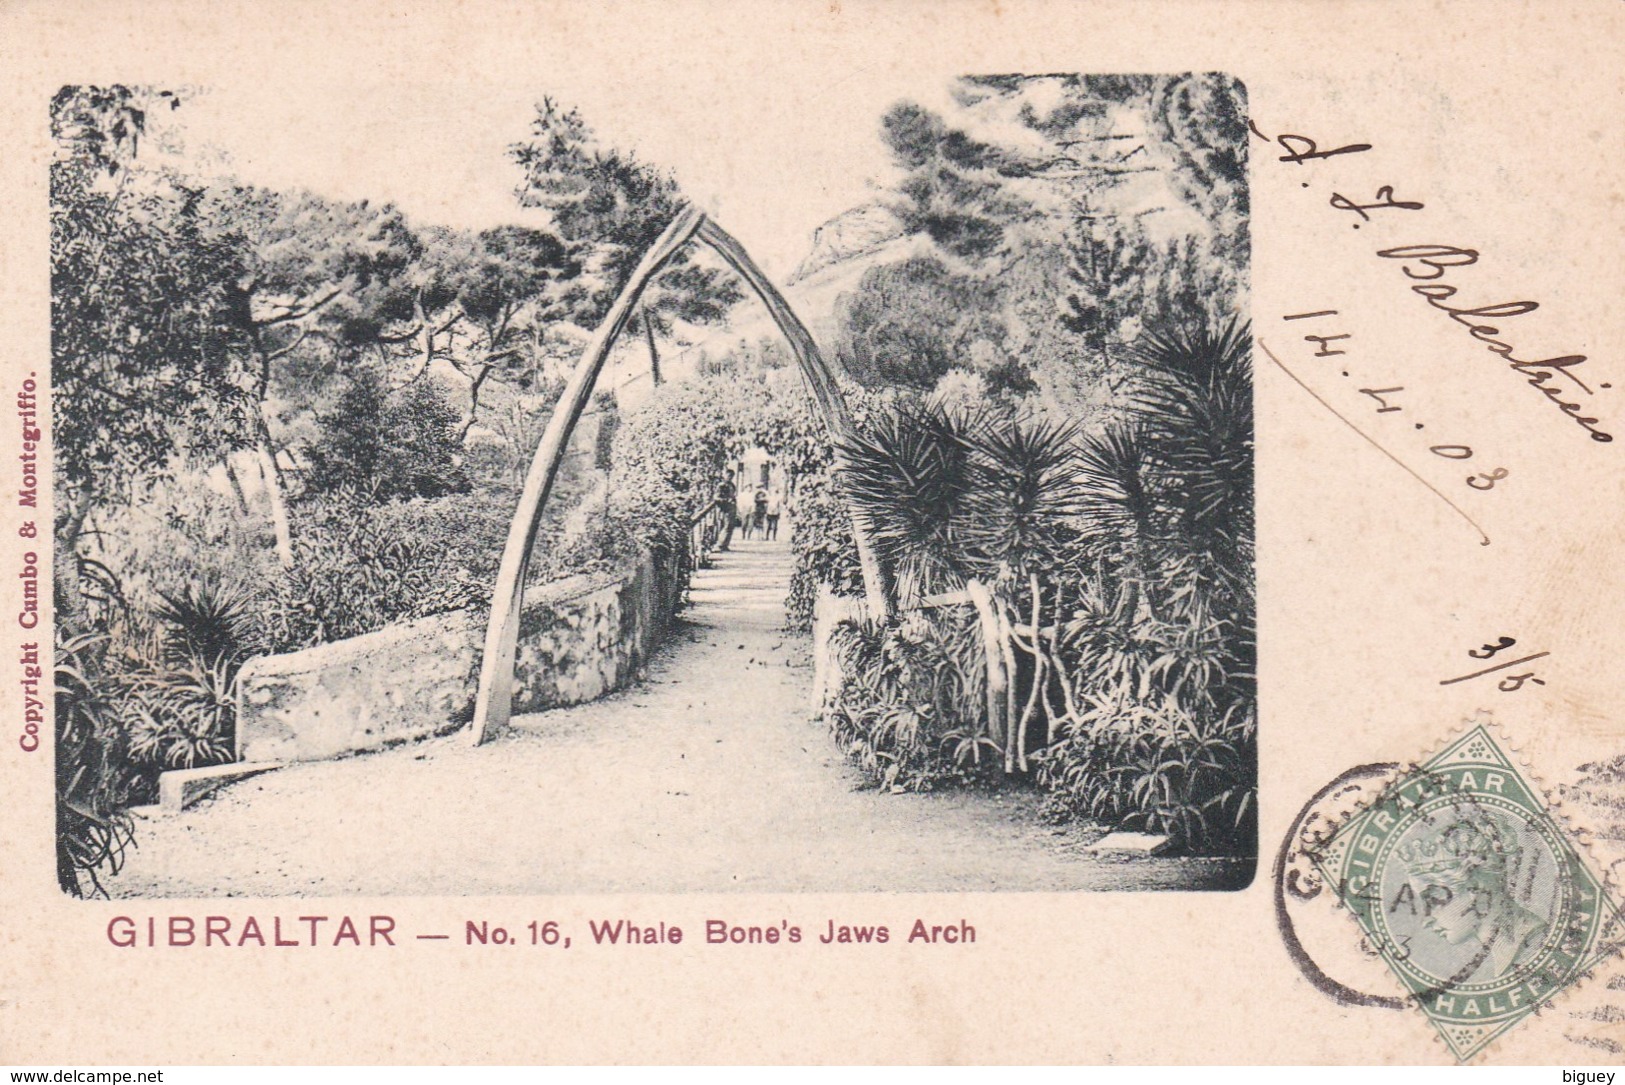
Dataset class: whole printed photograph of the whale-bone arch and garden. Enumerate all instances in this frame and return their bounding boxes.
[41,71,1271,896]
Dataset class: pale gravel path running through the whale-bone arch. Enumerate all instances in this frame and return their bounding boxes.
[111,541,1245,897]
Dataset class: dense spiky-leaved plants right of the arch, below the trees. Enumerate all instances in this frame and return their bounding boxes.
[812,325,1256,853]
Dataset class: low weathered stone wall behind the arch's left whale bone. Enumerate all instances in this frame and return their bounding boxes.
[237,559,681,762]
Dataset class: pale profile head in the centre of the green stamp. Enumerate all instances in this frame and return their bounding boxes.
[1396,809,1552,983]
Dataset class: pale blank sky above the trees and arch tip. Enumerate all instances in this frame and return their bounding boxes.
[163,79,946,279]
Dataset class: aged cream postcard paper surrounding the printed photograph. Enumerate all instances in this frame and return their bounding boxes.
[0,0,1625,1066]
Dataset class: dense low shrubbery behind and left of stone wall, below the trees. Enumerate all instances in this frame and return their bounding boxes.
[55,375,619,893]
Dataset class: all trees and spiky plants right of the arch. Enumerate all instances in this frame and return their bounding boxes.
[790,75,1256,854]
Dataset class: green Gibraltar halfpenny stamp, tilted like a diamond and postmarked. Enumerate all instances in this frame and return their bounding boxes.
[1313,726,1620,1061]
